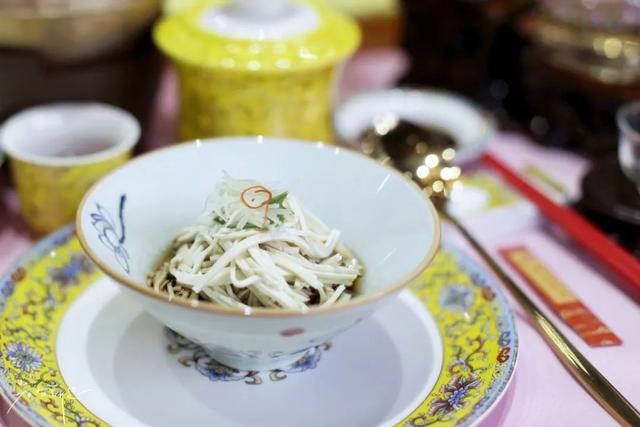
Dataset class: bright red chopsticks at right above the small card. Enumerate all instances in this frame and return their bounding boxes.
[482,153,640,299]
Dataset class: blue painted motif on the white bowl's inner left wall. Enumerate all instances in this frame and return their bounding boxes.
[90,194,131,274]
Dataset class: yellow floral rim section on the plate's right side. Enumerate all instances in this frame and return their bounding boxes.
[400,247,518,427]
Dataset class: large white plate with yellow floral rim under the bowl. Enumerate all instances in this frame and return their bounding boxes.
[0,227,518,426]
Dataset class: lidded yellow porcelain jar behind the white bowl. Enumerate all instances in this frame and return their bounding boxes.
[154,0,360,142]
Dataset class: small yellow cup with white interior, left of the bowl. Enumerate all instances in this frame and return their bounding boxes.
[0,103,140,233]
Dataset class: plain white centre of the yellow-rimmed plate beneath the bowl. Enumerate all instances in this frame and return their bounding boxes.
[57,278,442,427]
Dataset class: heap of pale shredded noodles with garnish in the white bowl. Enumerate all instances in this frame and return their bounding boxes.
[147,175,363,310]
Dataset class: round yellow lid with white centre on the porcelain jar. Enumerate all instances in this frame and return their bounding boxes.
[154,0,360,72]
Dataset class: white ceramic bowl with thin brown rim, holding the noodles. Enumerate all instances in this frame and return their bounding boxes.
[76,137,440,370]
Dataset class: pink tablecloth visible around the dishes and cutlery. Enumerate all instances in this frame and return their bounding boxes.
[0,51,640,427]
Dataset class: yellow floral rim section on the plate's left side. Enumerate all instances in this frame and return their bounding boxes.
[0,228,104,426]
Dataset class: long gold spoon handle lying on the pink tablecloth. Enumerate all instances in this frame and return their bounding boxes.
[442,209,640,427]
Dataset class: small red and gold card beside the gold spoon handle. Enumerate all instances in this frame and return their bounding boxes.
[500,246,622,347]
